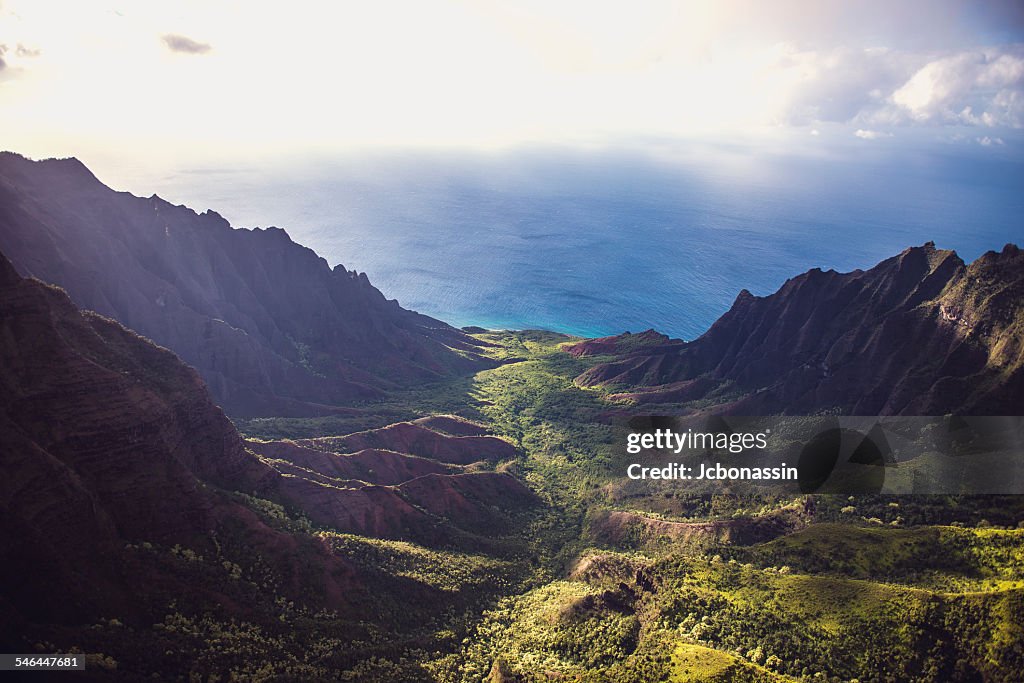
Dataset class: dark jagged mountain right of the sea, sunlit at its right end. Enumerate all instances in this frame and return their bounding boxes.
[568,244,1024,415]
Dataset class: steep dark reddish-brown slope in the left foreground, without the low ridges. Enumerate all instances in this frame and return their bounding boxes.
[0,249,358,628]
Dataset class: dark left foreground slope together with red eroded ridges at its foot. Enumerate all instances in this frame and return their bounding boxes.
[0,248,536,642]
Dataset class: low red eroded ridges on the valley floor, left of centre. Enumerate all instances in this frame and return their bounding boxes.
[249,418,538,545]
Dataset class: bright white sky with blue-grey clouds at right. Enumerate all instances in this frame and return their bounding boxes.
[0,0,1024,162]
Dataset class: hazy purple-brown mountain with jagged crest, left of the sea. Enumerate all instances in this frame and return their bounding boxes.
[0,153,486,416]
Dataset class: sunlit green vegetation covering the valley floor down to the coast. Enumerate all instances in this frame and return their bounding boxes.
[34,332,1024,683]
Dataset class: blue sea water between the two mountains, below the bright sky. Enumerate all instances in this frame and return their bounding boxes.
[114,141,1024,339]
